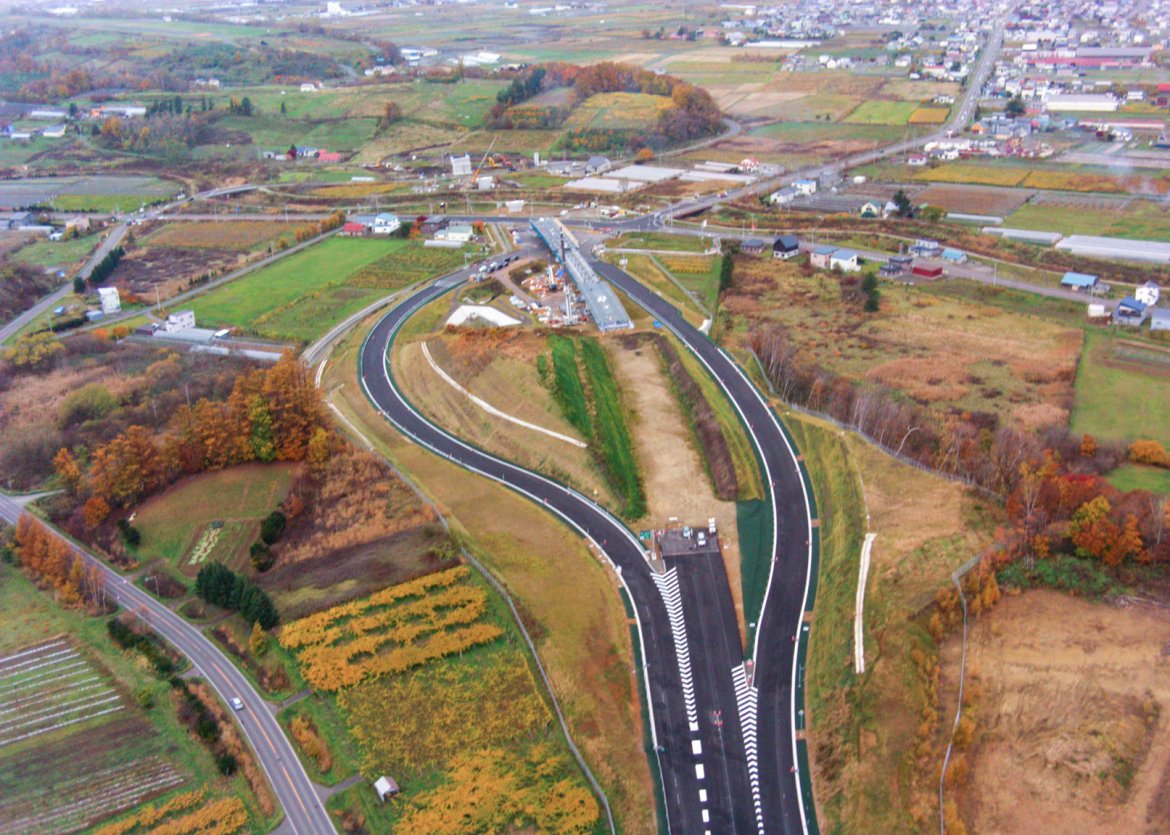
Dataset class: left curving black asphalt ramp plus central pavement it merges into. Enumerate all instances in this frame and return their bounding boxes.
[360,263,758,834]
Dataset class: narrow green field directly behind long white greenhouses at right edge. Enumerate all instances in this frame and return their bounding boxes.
[1005,200,1170,241]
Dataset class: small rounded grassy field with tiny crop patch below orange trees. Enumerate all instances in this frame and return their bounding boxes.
[135,464,294,577]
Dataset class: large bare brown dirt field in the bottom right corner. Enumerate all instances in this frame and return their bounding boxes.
[942,591,1170,835]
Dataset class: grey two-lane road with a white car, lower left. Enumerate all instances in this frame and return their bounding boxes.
[0,494,337,835]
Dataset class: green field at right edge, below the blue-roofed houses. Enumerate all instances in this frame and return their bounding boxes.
[1072,330,1170,446]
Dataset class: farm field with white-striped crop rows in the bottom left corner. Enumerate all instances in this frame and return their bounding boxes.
[0,564,263,834]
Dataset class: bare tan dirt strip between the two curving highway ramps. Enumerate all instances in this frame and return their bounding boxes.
[610,332,744,640]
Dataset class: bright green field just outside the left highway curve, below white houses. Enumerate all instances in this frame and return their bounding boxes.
[190,232,463,341]
